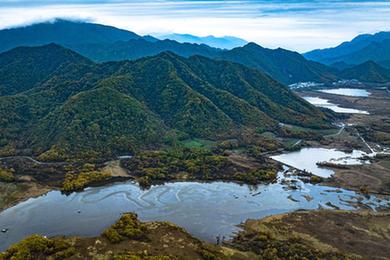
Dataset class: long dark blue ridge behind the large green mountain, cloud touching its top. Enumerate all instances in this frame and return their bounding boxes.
[0,20,337,84]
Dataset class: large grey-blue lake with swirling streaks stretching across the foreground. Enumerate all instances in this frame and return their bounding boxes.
[0,167,389,250]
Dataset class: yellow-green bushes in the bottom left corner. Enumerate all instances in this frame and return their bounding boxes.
[0,235,76,260]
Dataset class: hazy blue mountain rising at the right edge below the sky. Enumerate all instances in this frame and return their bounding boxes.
[304,32,390,68]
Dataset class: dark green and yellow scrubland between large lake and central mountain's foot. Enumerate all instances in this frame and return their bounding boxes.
[122,148,277,187]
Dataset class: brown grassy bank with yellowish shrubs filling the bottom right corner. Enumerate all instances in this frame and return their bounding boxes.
[229,210,390,259]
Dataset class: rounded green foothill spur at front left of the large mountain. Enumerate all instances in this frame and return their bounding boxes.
[31,84,165,157]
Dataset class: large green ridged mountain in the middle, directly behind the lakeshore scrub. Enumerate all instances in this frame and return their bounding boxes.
[0,44,328,159]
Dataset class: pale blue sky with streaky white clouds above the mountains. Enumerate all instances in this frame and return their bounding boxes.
[0,0,390,52]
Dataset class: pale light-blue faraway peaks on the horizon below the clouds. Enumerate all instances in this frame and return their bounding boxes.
[159,33,248,50]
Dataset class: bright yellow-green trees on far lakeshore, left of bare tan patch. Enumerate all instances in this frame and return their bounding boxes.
[62,171,111,192]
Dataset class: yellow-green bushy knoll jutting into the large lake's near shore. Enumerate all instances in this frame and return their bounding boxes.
[103,213,146,243]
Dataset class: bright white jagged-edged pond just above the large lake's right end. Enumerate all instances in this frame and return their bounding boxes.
[271,148,369,178]
